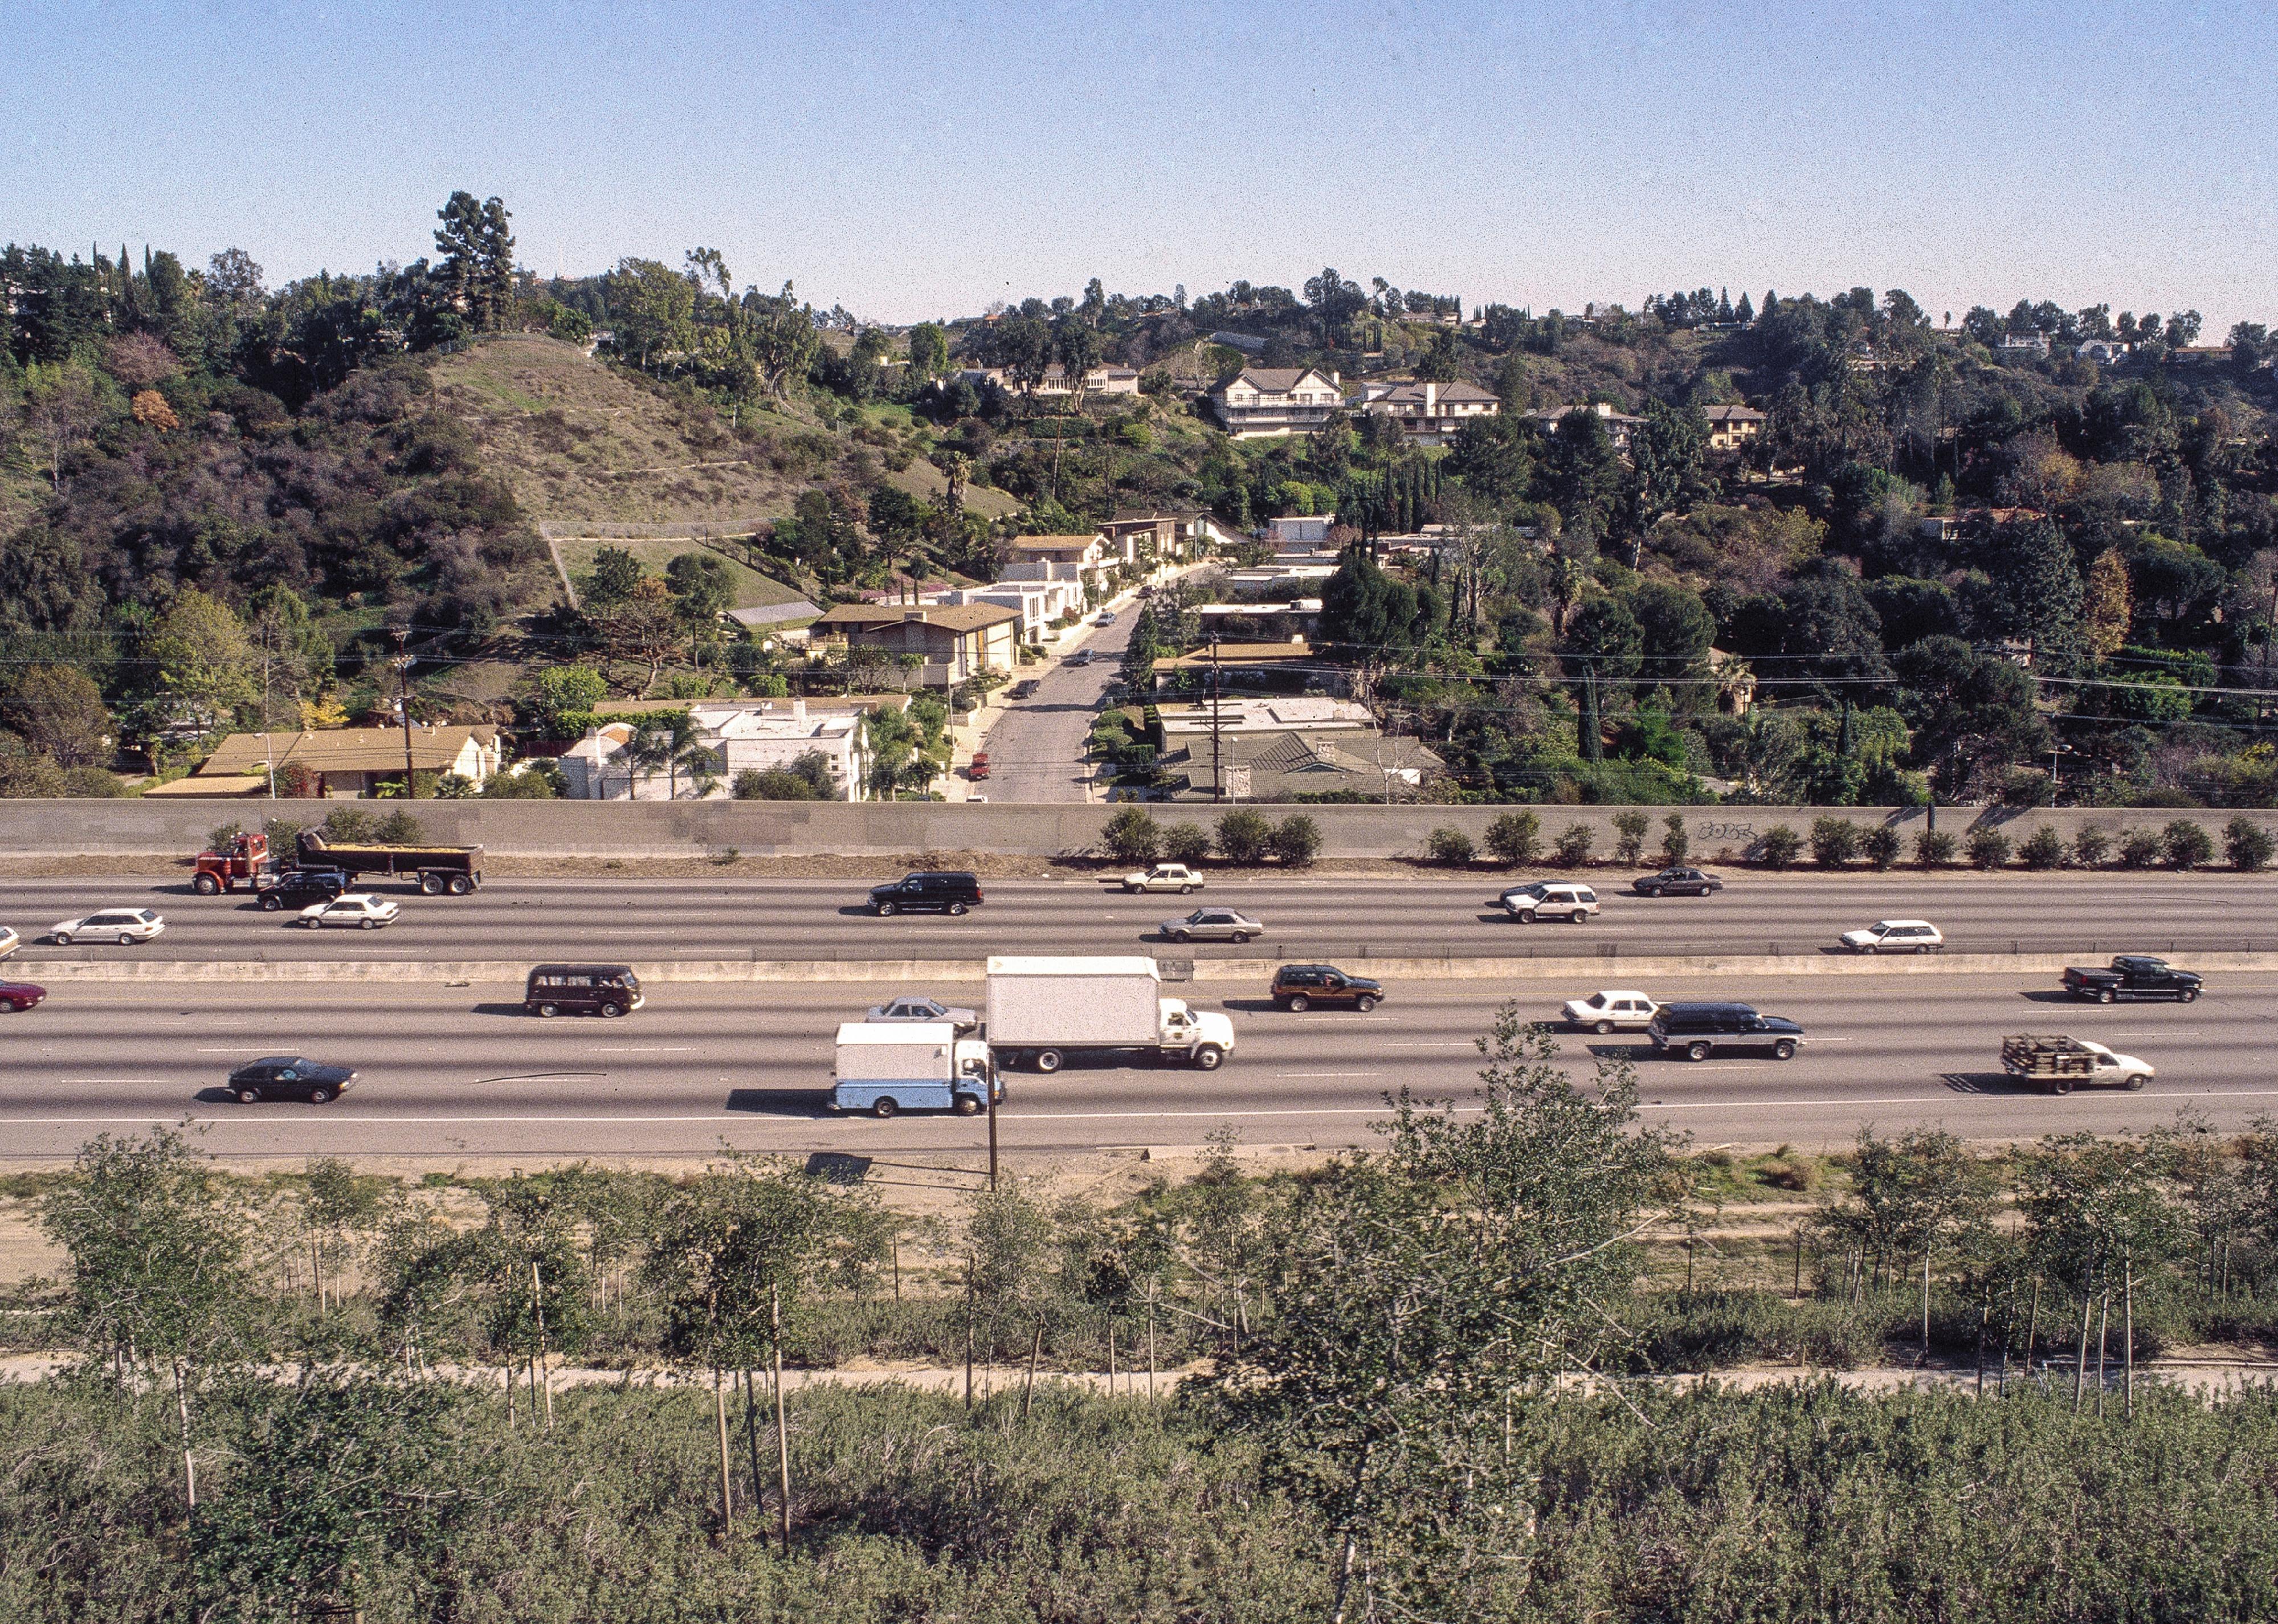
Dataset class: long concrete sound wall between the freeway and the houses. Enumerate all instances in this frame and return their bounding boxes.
[0,799,2278,863]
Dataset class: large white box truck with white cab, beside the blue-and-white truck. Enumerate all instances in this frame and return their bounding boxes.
[984,957,1235,1071]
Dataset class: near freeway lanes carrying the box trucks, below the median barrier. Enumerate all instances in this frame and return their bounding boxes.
[0,975,2278,1166]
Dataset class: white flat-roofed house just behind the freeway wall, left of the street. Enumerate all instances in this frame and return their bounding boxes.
[561,699,870,802]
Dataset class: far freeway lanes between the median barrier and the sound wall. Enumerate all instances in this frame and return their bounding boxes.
[0,868,2278,977]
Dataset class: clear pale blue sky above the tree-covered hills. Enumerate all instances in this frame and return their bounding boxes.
[0,0,2278,337]
